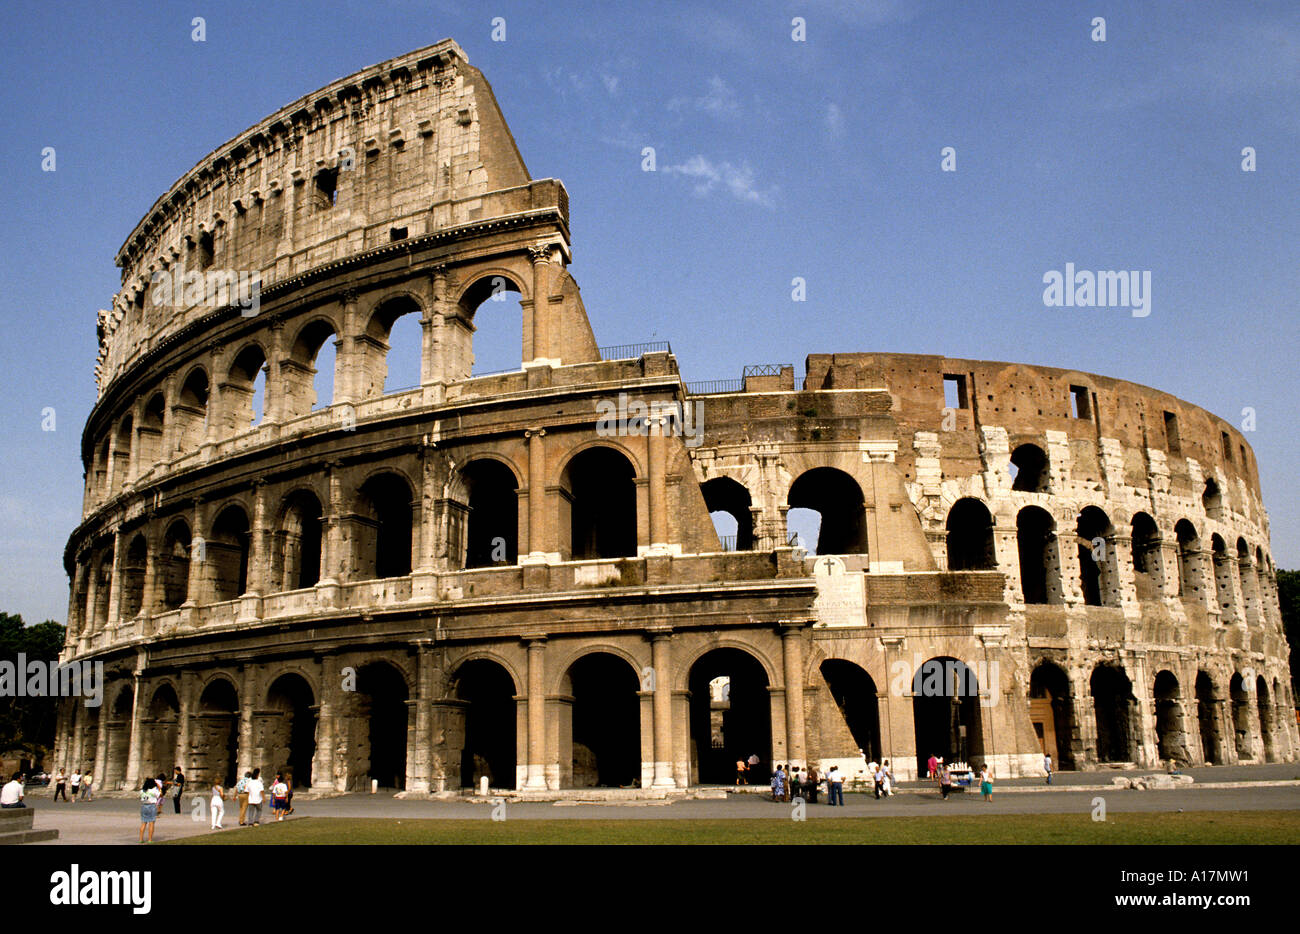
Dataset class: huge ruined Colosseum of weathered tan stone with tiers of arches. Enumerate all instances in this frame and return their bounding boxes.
[55,40,1300,796]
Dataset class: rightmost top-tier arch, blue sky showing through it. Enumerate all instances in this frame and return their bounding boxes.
[447,276,520,380]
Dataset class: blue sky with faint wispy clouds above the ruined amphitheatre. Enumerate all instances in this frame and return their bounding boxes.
[0,0,1300,622]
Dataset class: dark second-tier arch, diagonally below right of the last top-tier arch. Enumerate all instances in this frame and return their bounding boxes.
[561,447,637,561]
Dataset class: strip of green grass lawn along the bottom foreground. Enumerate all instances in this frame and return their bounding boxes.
[169,810,1300,846]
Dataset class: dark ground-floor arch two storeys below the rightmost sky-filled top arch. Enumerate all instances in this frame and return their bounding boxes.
[455,658,519,788]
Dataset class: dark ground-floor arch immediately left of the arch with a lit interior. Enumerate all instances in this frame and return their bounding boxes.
[562,652,641,788]
